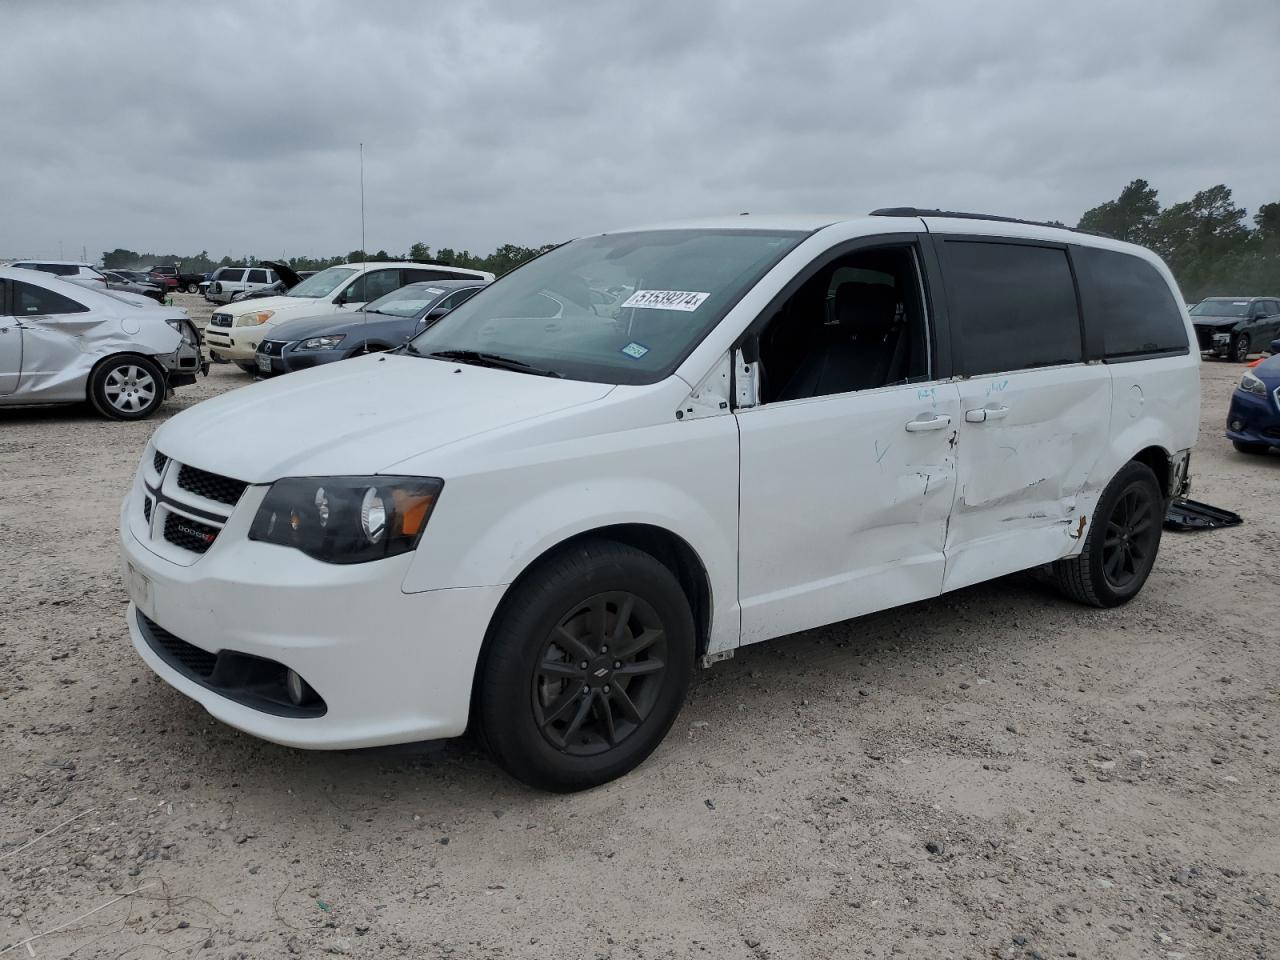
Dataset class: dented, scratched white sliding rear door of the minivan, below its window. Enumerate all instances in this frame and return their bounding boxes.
[943,364,1111,590]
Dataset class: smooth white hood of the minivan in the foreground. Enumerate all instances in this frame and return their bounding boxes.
[155,353,614,484]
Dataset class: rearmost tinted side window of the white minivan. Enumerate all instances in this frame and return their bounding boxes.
[1074,247,1187,358]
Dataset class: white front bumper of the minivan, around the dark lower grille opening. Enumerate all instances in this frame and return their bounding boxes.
[120,479,503,749]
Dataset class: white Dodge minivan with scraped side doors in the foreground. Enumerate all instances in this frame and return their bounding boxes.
[120,209,1199,790]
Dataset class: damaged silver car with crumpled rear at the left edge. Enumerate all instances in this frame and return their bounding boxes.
[0,268,209,420]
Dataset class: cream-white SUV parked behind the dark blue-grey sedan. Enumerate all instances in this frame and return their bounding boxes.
[205,261,493,372]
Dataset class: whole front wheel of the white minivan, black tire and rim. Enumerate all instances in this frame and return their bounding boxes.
[474,540,695,792]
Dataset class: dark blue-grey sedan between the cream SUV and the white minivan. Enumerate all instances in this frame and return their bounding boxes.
[256,280,488,376]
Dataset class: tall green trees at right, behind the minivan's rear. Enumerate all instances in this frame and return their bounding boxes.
[1078,180,1280,303]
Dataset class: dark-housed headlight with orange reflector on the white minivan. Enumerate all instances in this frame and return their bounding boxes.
[248,476,444,563]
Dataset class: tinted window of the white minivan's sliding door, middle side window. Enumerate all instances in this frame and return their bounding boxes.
[943,241,1084,375]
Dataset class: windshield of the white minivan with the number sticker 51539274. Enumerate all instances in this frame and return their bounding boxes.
[411,229,808,384]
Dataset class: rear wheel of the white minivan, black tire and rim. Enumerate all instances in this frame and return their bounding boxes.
[1053,461,1165,607]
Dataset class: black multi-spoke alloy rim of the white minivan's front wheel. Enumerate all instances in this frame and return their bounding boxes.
[531,591,667,756]
